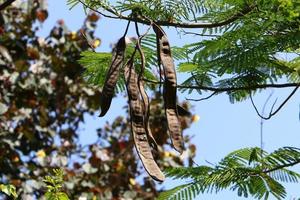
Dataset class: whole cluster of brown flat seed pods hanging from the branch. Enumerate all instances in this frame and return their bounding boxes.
[100,25,183,181]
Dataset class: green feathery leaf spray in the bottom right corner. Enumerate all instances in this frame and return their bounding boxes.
[158,147,300,200]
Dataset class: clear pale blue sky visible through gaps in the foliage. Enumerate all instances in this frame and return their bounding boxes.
[39,1,300,200]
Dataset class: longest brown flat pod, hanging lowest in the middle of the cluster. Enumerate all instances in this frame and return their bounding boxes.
[124,59,165,181]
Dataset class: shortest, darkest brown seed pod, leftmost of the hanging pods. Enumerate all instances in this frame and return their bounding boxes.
[99,37,126,117]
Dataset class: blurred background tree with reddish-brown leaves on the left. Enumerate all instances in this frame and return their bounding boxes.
[0,0,195,199]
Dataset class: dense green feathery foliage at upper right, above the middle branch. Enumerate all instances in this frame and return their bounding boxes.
[179,1,300,102]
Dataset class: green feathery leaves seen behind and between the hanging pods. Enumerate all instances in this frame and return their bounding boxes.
[78,34,187,93]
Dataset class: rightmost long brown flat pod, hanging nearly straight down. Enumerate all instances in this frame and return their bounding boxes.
[153,25,184,153]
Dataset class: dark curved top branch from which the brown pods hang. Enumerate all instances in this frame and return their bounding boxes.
[78,0,255,28]
